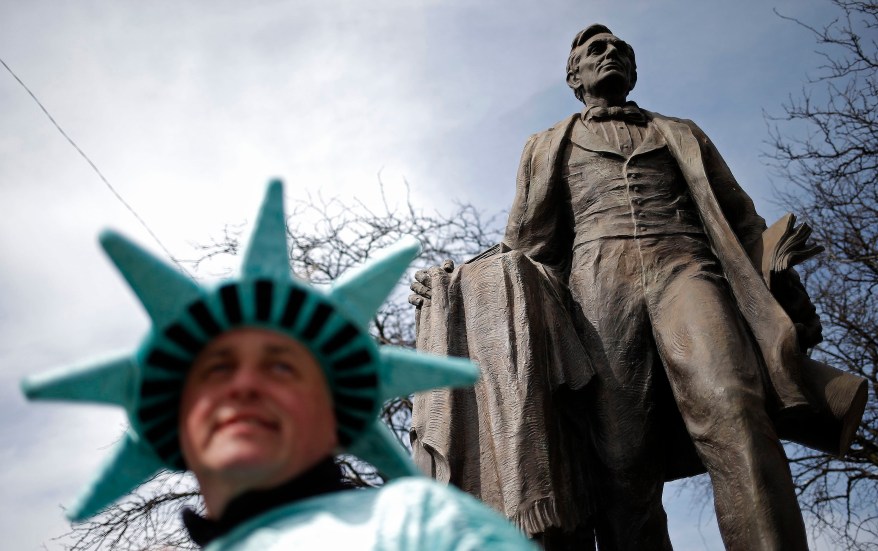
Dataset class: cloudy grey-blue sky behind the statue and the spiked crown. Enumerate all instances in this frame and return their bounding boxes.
[0,0,852,550]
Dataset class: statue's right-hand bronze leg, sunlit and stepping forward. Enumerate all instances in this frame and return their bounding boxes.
[644,238,807,550]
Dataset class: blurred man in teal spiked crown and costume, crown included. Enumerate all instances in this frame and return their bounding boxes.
[22,182,533,551]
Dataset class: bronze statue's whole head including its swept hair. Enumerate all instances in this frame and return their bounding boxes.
[567,24,637,102]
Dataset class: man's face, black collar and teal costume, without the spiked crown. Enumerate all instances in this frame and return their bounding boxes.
[180,327,530,550]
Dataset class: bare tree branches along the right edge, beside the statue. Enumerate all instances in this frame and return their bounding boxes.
[767,0,878,549]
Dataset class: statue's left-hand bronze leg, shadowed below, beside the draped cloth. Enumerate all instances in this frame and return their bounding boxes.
[569,239,671,551]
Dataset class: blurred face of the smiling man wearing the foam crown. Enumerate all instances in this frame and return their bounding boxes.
[179,328,337,489]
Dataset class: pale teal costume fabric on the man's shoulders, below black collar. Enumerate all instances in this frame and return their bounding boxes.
[205,477,536,551]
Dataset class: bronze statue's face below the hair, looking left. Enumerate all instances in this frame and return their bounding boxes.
[567,33,634,97]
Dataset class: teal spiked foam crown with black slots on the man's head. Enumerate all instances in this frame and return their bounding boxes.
[21,181,478,521]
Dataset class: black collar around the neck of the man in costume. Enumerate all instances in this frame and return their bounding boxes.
[183,457,353,547]
